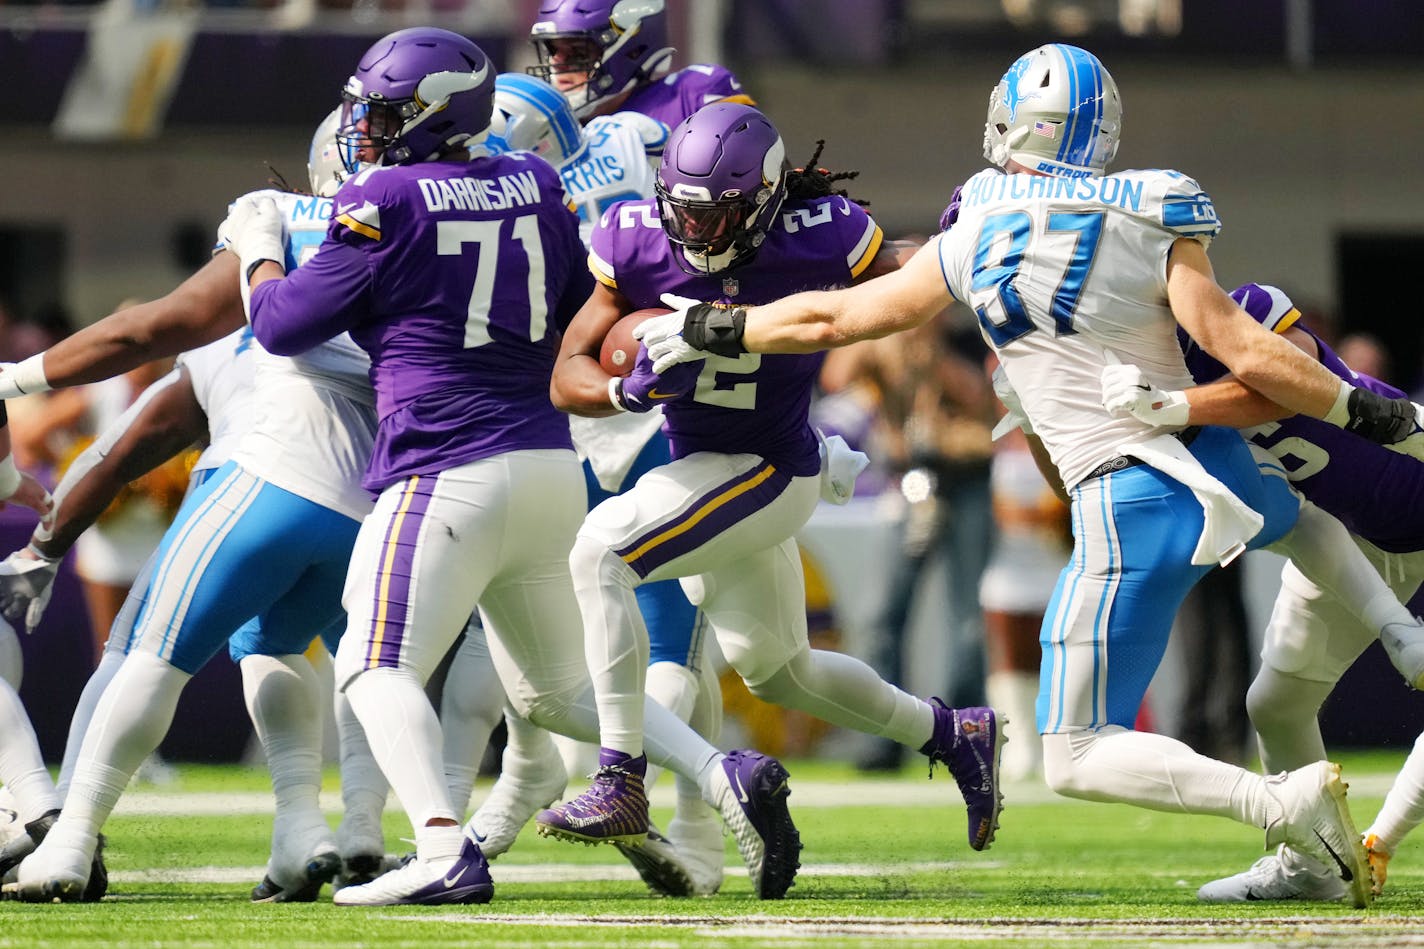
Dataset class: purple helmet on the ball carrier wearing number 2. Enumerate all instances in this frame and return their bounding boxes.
[655,103,786,274]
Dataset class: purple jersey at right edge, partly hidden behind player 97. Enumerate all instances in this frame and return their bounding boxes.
[1178,306,1424,553]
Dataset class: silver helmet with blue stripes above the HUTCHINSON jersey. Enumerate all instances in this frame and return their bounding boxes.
[984,43,1122,178]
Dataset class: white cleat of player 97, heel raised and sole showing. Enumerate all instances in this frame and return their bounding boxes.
[1266,761,1373,909]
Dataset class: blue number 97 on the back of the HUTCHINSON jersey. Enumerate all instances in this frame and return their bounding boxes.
[970,211,1104,346]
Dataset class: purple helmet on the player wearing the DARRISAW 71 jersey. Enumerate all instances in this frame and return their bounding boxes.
[336,27,494,172]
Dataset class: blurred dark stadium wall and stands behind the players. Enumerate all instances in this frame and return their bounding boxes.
[0,0,1424,758]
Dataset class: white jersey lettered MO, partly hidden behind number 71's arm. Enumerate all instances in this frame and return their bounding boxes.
[224,192,376,519]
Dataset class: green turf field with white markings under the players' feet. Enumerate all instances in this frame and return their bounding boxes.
[0,754,1424,949]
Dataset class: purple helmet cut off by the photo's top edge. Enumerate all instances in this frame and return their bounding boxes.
[528,0,672,118]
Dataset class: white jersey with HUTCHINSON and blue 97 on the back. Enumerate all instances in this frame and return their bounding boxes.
[937,168,1220,487]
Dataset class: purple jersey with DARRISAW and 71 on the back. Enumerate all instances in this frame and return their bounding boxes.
[252,152,592,492]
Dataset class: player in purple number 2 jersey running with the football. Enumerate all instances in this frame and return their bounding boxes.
[535,103,1002,866]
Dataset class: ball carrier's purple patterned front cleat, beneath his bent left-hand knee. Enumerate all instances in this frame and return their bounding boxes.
[534,748,648,844]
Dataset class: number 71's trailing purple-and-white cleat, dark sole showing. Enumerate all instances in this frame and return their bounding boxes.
[713,751,800,899]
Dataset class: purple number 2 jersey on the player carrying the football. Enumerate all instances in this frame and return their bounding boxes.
[588,197,883,476]
